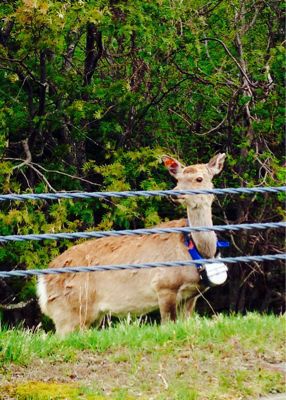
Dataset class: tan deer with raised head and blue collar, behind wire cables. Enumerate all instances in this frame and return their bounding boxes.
[37,153,225,336]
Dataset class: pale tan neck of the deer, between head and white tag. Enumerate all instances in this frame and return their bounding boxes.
[187,205,217,258]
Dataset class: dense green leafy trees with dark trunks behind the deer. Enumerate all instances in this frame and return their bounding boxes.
[0,0,285,324]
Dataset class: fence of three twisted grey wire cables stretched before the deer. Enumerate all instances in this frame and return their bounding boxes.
[0,186,286,278]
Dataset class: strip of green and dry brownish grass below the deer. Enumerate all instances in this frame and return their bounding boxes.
[0,314,286,400]
